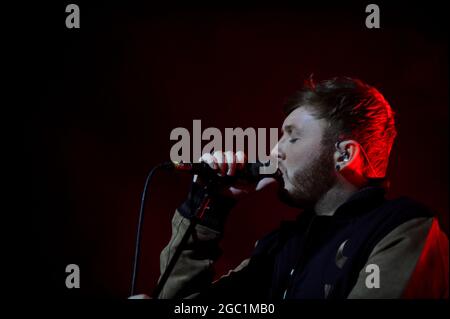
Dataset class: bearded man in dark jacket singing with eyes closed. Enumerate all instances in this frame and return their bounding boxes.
[142,78,448,301]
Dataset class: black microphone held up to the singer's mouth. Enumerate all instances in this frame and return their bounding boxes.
[164,161,281,182]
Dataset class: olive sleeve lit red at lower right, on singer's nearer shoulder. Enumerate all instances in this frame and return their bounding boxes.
[348,218,448,299]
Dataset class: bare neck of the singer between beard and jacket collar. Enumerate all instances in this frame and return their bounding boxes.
[314,183,359,216]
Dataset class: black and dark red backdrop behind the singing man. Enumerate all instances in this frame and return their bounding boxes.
[26,1,449,298]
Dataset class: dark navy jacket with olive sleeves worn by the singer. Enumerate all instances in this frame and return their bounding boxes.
[156,186,449,301]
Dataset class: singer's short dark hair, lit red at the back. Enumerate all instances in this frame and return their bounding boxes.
[284,76,397,178]
